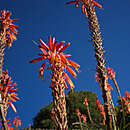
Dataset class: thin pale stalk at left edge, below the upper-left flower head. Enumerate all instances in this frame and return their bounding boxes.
[0,30,8,130]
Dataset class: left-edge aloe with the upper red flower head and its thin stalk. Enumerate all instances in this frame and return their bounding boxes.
[0,10,18,130]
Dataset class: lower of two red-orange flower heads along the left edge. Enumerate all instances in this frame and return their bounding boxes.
[0,70,19,113]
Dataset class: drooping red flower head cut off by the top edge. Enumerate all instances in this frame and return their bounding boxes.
[66,0,102,17]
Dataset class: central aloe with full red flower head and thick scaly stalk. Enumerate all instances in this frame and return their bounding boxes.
[30,35,80,129]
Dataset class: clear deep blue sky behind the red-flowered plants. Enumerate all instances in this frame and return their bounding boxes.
[1,0,130,127]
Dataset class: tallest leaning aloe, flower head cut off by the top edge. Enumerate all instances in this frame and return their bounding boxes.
[67,0,116,130]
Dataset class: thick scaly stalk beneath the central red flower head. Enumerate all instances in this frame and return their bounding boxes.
[51,62,68,130]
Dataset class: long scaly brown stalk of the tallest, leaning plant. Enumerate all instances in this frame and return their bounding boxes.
[86,4,115,130]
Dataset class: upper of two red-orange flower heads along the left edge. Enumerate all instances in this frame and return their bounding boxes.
[0,10,18,47]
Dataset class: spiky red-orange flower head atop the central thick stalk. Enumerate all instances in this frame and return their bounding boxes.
[30,35,80,89]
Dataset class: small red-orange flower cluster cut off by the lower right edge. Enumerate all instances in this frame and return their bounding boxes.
[122,91,130,114]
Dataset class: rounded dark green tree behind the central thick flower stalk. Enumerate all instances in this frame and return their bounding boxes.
[33,91,102,129]
